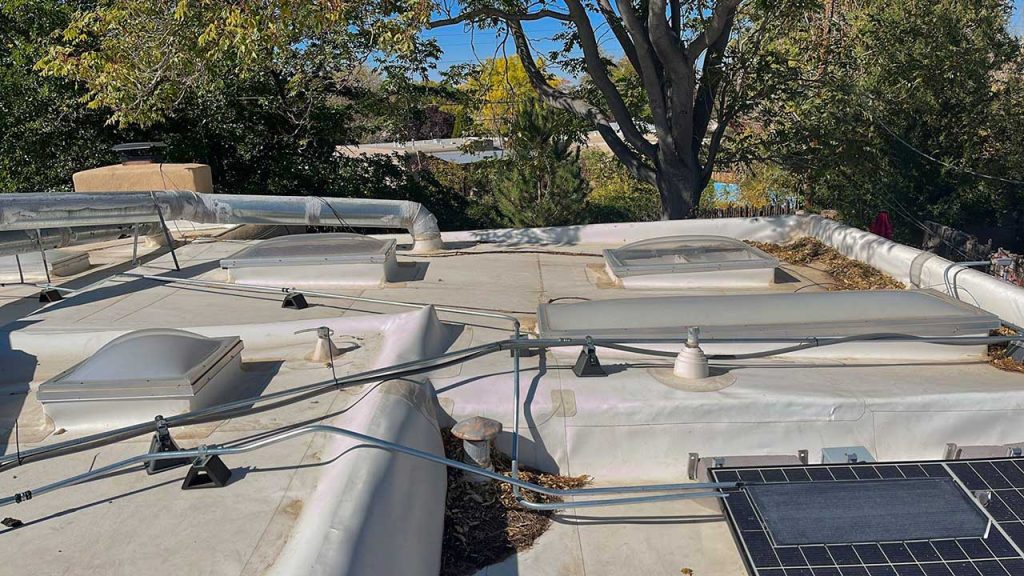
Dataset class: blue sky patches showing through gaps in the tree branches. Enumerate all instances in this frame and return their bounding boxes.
[428,0,1024,78]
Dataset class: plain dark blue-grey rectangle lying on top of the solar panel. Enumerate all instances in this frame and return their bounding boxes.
[746,478,988,545]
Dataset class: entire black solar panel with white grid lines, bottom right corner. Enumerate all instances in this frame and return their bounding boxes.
[709,458,1024,576]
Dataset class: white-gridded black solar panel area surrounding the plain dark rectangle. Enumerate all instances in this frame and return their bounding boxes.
[709,457,1024,576]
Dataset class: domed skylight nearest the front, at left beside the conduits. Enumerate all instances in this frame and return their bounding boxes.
[38,328,243,429]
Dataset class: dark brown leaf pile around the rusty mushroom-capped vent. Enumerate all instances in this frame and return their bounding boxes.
[441,428,590,576]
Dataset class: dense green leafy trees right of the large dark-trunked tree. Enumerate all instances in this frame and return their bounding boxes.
[743,0,1024,233]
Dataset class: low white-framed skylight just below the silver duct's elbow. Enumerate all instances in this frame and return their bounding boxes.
[220,234,397,289]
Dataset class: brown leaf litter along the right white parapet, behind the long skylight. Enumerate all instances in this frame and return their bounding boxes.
[748,237,905,290]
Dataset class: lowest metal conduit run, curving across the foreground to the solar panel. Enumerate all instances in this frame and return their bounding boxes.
[0,424,738,509]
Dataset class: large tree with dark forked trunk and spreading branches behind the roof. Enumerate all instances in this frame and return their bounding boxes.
[428,0,809,218]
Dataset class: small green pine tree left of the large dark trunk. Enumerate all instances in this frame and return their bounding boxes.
[495,104,588,228]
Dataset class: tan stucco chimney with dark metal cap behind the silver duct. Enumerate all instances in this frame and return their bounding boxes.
[72,142,213,194]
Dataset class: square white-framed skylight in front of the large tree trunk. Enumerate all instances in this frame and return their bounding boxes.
[604,236,779,288]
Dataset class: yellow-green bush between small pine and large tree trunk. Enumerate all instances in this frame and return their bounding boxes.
[580,151,662,222]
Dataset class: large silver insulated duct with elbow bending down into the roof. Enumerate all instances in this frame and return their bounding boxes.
[0,191,443,253]
